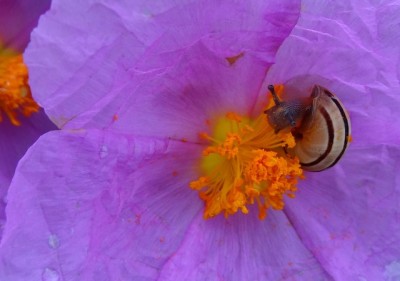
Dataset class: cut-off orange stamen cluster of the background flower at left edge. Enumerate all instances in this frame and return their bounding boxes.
[0,47,39,126]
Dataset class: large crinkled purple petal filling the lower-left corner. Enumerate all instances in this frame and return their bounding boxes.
[0,130,202,281]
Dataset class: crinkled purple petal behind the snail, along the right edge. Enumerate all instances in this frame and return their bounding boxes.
[267,1,400,280]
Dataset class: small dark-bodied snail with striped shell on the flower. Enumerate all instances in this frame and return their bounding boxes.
[265,85,351,172]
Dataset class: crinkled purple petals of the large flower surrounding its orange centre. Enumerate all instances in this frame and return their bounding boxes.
[0,1,400,280]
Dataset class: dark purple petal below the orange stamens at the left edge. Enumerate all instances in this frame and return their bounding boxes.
[0,111,56,237]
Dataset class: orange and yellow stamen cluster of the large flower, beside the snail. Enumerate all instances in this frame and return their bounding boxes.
[190,85,303,219]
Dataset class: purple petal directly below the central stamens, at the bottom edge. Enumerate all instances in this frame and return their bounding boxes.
[160,210,330,281]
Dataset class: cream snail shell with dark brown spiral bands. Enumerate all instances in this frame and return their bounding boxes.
[293,85,351,171]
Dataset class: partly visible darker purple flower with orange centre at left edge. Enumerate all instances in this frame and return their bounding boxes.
[0,0,55,234]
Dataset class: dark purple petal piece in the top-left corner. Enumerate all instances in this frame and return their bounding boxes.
[0,0,51,51]
